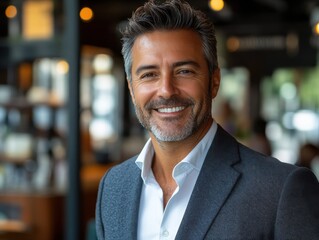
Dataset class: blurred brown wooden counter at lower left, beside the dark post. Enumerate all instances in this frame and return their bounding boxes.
[0,192,65,240]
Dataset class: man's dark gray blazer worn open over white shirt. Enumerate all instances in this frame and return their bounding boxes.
[96,126,319,240]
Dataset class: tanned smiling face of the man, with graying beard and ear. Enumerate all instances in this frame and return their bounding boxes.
[129,30,219,141]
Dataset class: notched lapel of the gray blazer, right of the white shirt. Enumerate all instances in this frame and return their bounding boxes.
[176,126,240,239]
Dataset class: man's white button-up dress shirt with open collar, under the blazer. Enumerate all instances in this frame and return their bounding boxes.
[136,121,217,240]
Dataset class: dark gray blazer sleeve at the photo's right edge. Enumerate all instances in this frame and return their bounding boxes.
[275,168,319,240]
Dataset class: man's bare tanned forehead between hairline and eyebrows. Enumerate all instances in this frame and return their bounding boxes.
[132,29,204,67]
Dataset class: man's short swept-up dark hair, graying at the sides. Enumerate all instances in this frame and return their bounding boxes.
[121,0,218,81]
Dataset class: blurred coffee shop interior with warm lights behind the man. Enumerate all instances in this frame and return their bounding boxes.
[0,0,319,240]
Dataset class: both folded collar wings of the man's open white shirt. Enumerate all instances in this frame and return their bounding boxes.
[135,121,217,182]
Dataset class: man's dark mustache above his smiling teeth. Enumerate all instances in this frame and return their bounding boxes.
[145,96,194,110]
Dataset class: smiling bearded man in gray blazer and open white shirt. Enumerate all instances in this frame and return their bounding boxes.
[96,0,319,240]
